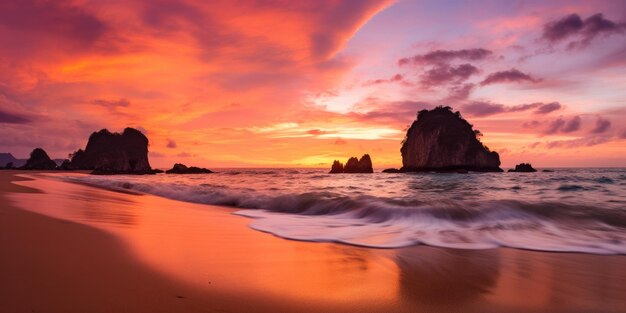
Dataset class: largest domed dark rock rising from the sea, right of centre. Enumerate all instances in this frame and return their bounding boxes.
[400,107,502,172]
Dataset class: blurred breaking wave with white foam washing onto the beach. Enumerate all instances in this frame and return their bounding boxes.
[62,177,626,254]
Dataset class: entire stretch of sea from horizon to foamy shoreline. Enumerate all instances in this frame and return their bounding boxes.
[64,168,626,254]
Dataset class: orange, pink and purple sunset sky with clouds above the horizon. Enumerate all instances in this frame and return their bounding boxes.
[0,0,626,168]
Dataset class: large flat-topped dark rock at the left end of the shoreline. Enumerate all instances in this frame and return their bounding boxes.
[71,128,157,175]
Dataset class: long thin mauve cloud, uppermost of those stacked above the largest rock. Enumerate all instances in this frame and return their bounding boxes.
[398,48,493,66]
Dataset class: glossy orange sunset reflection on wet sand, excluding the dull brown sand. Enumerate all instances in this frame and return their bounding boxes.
[2,173,626,312]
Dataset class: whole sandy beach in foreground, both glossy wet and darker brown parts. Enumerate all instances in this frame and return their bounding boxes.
[0,171,626,312]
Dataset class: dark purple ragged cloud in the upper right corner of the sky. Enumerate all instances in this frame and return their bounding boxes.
[541,13,626,49]
